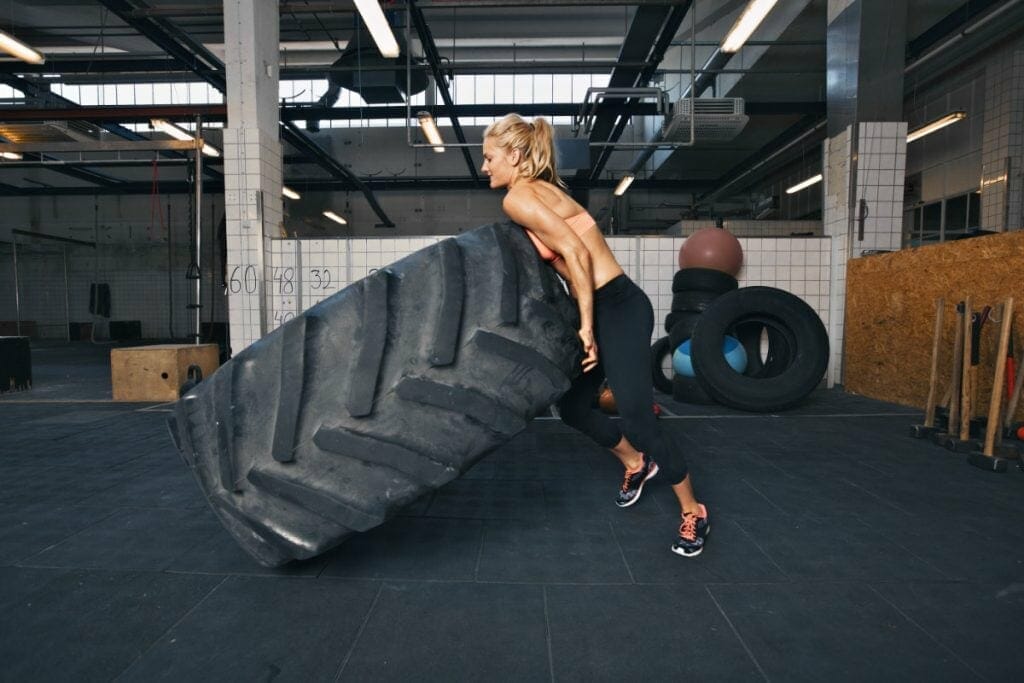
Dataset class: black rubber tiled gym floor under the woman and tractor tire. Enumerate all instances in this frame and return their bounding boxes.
[0,344,1024,681]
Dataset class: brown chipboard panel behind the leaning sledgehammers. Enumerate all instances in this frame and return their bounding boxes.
[844,231,1024,420]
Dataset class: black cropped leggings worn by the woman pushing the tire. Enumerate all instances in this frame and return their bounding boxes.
[558,274,686,484]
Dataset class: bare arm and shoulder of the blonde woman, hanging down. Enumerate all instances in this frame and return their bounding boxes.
[502,187,597,372]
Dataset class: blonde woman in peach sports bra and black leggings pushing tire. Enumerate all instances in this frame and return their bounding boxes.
[480,114,710,557]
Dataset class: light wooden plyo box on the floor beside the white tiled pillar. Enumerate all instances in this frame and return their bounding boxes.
[111,344,219,401]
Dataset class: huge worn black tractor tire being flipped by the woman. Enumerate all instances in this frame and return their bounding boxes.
[171,224,582,566]
